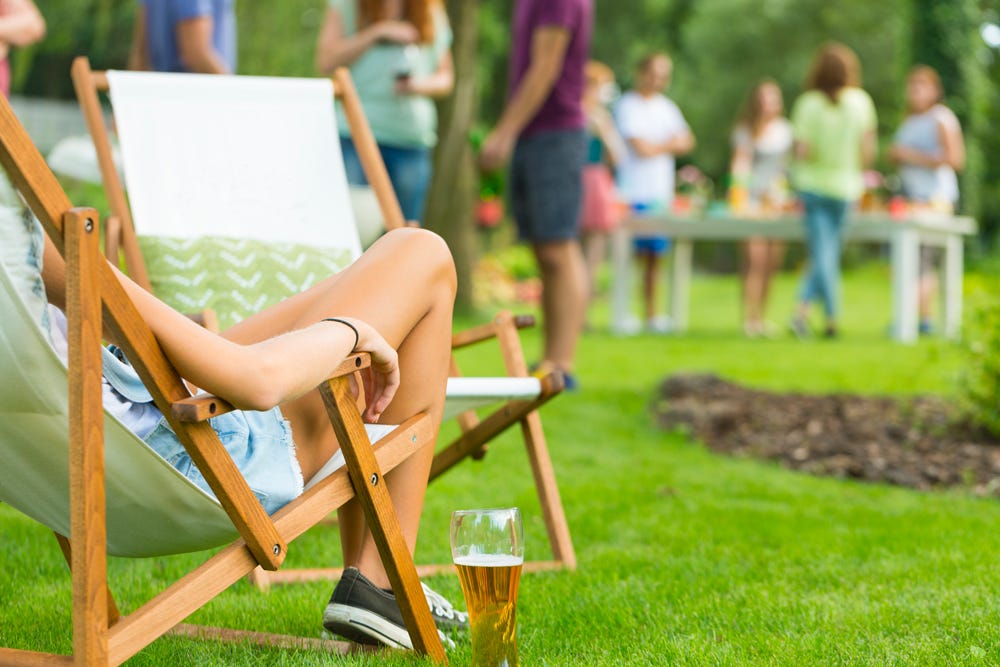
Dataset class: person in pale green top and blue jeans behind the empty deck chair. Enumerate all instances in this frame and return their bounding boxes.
[316,0,455,222]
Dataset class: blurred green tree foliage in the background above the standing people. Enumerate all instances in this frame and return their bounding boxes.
[13,0,1000,240]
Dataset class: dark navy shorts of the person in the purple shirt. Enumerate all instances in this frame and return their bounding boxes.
[510,129,587,243]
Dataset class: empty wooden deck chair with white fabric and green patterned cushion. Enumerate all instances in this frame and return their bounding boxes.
[73,58,576,580]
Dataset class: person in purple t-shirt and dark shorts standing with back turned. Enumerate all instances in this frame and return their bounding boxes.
[479,0,593,389]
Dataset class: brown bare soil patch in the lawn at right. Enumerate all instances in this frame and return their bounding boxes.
[653,375,1000,496]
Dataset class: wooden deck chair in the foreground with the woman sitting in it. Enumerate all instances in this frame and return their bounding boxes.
[0,92,446,665]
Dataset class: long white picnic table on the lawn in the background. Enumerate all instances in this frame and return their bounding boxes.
[611,211,977,343]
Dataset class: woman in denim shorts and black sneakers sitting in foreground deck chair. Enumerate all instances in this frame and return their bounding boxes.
[43,224,464,648]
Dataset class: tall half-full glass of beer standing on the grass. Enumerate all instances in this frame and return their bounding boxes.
[451,507,524,667]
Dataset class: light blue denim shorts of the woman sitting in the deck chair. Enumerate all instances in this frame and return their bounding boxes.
[145,408,303,514]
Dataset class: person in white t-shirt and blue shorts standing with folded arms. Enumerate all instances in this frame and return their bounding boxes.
[615,52,695,333]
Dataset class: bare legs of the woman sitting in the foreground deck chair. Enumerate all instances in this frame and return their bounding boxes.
[223,229,456,587]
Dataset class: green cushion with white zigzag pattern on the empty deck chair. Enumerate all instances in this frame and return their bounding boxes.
[139,237,352,329]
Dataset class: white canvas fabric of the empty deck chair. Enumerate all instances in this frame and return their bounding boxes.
[107,71,541,418]
